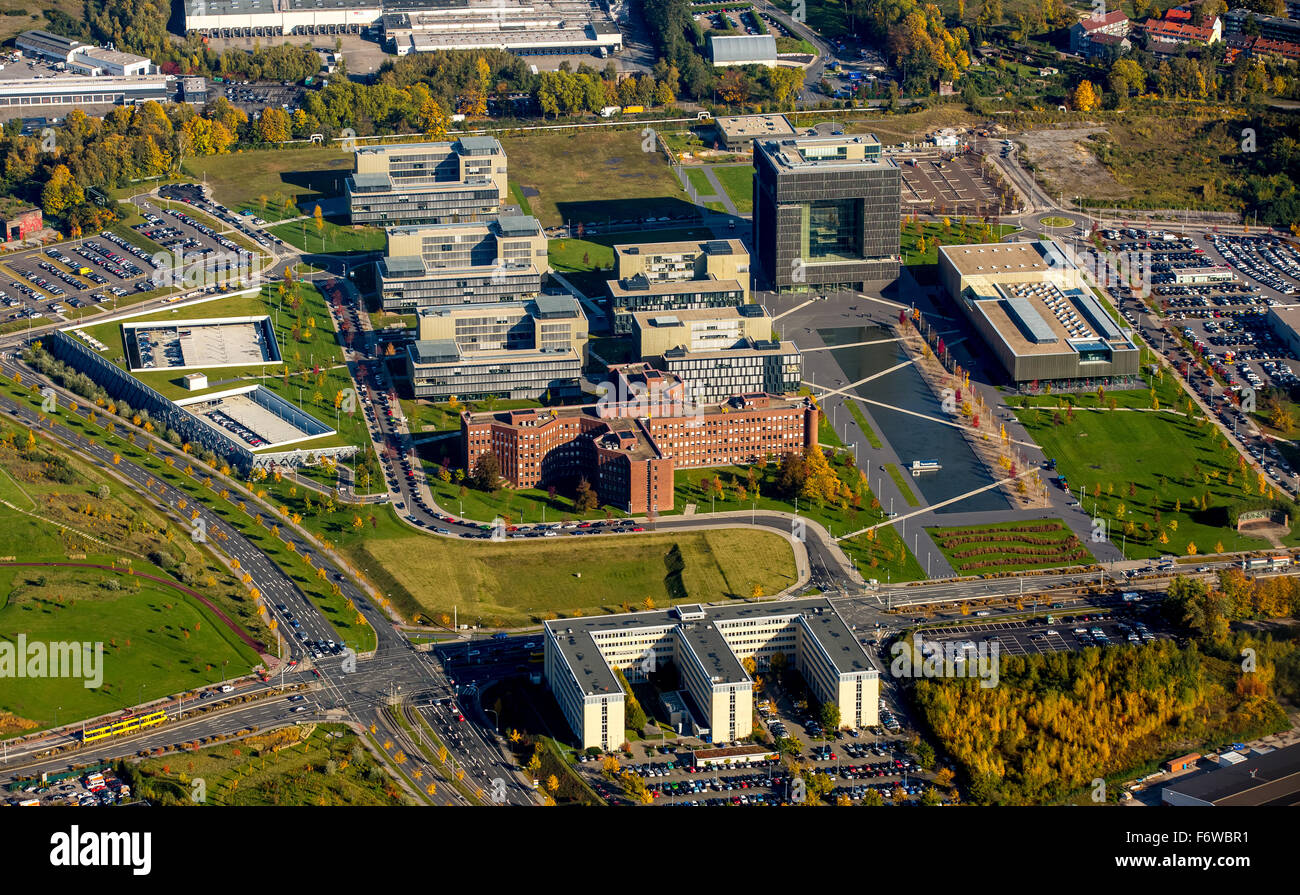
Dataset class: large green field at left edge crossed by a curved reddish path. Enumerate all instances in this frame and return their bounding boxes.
[0,416,273,734]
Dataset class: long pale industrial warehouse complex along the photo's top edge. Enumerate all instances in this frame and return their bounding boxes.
[185,0,623,56]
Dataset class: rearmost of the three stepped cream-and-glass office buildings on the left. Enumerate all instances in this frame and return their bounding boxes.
[346,137,507,226]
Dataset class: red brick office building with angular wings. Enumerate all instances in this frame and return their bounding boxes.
[460,390,818,513]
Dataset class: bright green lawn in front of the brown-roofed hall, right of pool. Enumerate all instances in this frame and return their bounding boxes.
[1018,408,1297,559]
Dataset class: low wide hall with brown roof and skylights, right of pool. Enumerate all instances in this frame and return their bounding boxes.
[939,241,1140,388]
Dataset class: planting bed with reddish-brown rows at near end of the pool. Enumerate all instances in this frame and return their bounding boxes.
[926,519,1092,575]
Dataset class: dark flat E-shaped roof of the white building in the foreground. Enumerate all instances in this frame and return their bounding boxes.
[545,597,876,696]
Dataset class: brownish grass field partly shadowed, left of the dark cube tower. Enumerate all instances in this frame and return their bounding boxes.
[501,130,693,226]
